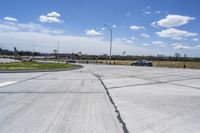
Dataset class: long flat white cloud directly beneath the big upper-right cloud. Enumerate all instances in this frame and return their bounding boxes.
[156,28,198,39]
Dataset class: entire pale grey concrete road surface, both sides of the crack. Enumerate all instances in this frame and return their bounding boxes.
[0,65,200,133]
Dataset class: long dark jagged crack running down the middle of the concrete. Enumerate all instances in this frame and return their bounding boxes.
[88,70,129,133]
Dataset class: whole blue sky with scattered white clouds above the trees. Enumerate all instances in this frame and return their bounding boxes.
[0,0,200,57]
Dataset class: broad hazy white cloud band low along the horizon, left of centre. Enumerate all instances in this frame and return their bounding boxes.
[0,31,155,55]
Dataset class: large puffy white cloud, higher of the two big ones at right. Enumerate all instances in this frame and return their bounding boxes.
[151,14,195,28]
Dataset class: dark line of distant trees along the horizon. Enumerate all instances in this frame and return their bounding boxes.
[0,48,200,61]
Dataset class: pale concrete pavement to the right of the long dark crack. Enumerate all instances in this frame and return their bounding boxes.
[85,65,200,133]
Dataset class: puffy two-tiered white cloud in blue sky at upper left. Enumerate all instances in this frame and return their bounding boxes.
[39,12,63,23]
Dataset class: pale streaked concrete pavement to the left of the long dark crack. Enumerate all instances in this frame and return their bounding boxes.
[0,69,123,133]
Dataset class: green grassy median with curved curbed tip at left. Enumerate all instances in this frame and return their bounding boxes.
[0,62,77,70]
